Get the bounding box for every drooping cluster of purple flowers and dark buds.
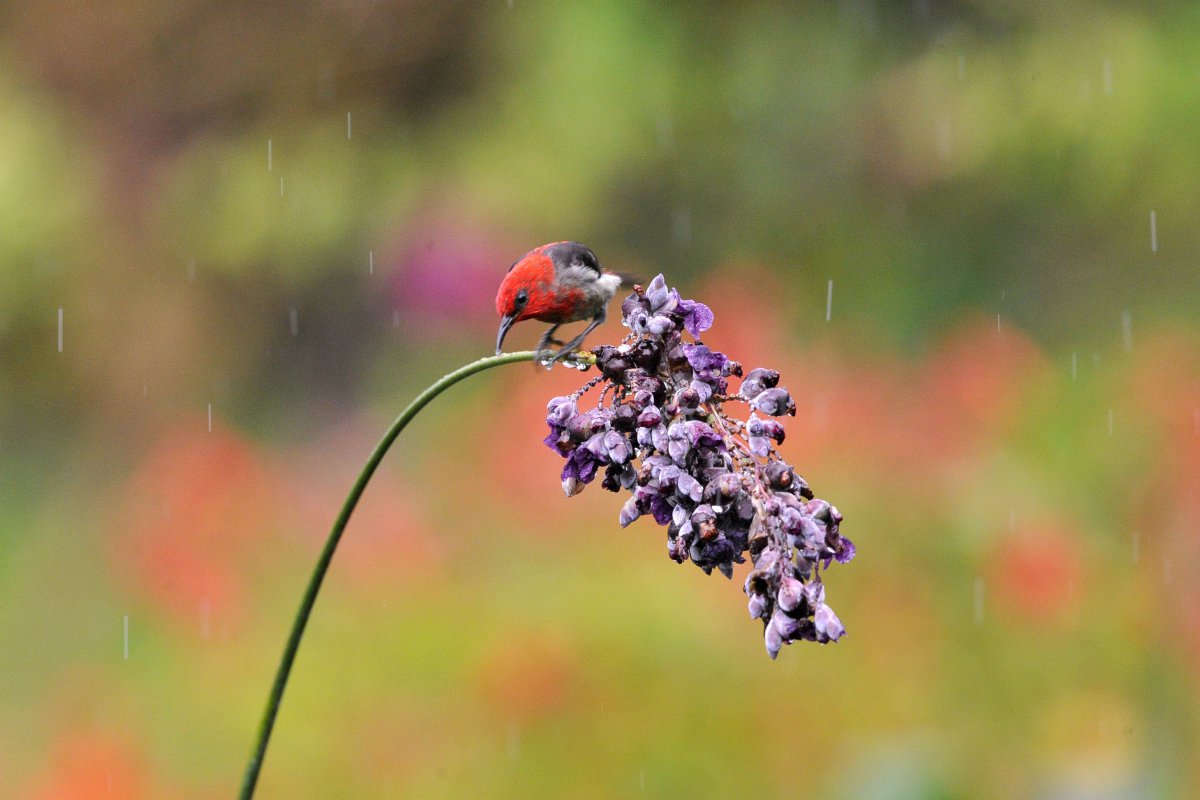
[546,275,854,658]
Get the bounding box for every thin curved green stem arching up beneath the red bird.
[238,350,534,800]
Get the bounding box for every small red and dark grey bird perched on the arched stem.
[496,241,624,363]
